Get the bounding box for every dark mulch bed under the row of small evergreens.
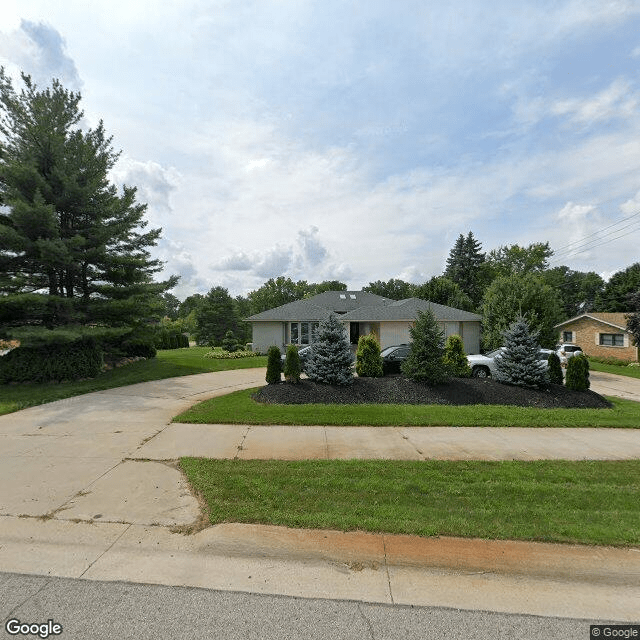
[253,375,612,409]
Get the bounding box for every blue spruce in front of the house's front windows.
[306,313,353,385]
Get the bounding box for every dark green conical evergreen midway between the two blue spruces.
[402,310,451,385]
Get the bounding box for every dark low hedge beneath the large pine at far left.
[0,336,102,384]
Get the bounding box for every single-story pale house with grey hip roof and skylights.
[246,291,481,353]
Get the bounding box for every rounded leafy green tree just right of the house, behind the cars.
[482,274,562,350]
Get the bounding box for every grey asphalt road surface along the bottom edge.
[0,573,616,640]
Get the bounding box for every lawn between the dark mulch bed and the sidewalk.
[174,389,640,428]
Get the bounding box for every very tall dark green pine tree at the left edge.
[0,68,177,327]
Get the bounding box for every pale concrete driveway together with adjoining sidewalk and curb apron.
[0,369,640,620]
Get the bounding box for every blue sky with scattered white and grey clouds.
[0,0,640,299]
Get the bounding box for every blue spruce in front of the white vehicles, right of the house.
[495,316,549,388]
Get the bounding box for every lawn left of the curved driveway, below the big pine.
[0,347,267,415]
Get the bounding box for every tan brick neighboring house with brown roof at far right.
[555,312,638,362]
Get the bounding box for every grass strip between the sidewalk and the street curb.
[181,458,640,545]
